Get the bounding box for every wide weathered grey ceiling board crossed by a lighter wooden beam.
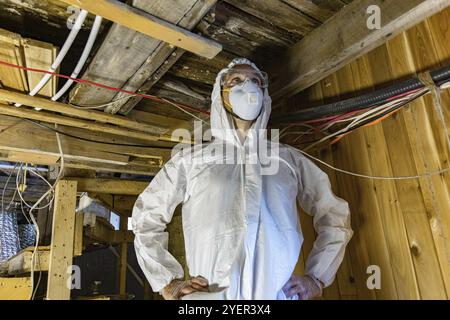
[70,0,216,114]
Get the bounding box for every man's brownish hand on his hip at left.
[161,276,209,300]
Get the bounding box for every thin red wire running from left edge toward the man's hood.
[0,60,210,116]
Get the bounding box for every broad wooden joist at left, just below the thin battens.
[0,114,171,175]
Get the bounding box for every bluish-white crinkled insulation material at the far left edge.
[0,212,19,263]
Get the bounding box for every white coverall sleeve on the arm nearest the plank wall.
[299,156,353,287]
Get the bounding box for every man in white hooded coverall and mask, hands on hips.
[133,58,352,299]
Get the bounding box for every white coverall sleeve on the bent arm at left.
[132,154,186,292]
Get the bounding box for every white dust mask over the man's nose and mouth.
[229,79,263,121]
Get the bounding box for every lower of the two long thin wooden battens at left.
[0,104,159,141]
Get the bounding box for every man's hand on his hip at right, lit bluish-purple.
[283,275,322,300]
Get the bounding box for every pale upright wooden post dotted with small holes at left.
[47,180,77,300]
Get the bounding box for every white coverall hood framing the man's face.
[211,58,272,144]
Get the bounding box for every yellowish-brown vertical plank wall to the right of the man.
[292,9,450,299]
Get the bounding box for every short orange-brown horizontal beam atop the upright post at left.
[71,178,149,195]
